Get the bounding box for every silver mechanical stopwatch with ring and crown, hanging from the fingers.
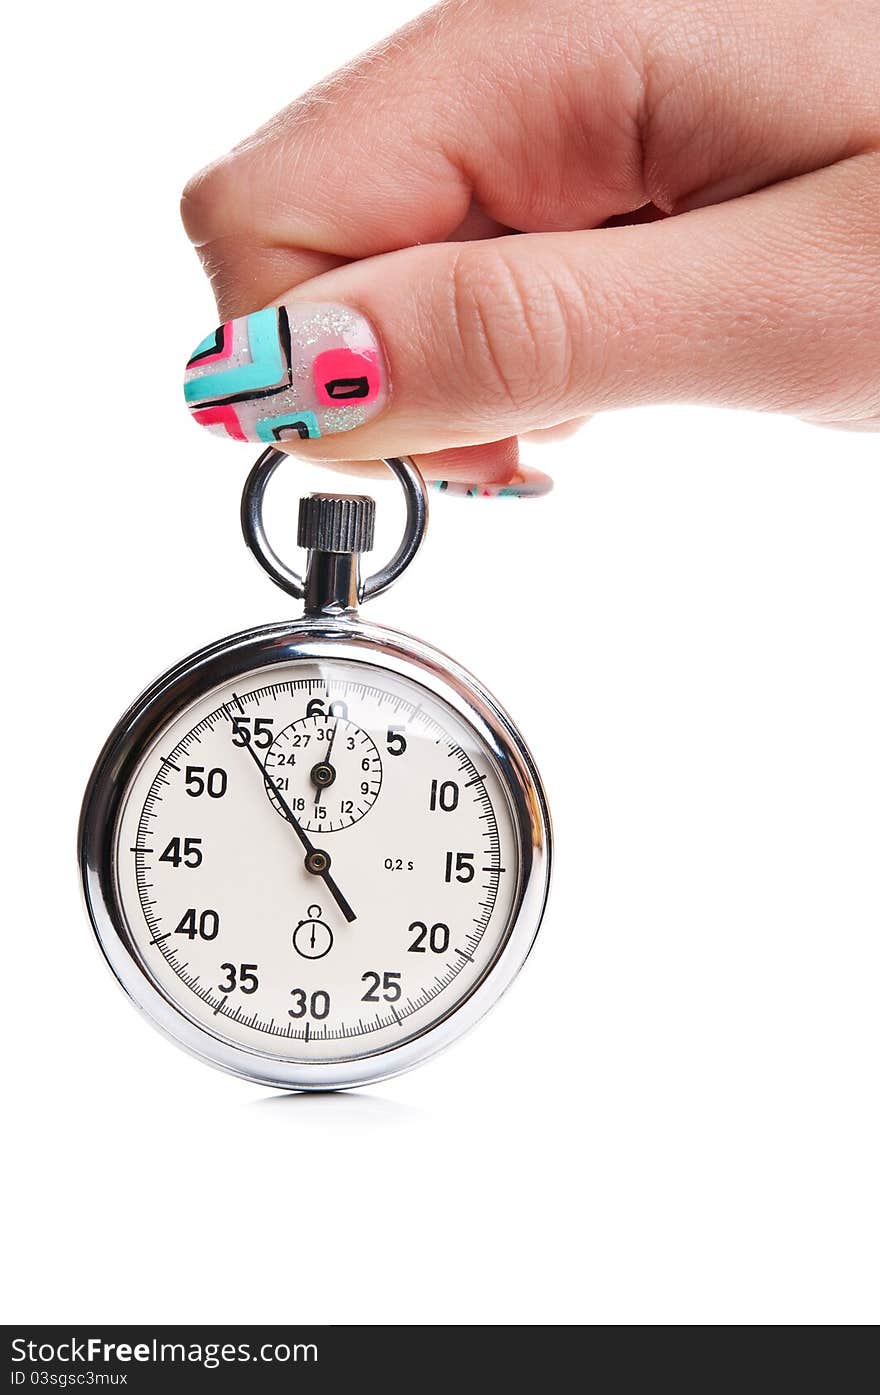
[79,449,551,1089]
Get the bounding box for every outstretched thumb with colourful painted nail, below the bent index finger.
[182,156,880,458]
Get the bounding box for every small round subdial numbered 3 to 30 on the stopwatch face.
[266,711,382,833]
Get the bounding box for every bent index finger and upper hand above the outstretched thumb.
[183,0,880,318]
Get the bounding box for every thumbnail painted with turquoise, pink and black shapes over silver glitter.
[184,304,388,445]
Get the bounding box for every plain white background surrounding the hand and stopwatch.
[1,0,880,1324]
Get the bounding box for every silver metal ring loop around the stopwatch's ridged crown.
[241,446,428,601]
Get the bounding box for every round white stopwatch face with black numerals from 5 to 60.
[82,624,552,1085]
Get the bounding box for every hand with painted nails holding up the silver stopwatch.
[183,0,880,491]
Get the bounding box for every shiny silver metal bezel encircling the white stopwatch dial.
[79,618,552,1089]
